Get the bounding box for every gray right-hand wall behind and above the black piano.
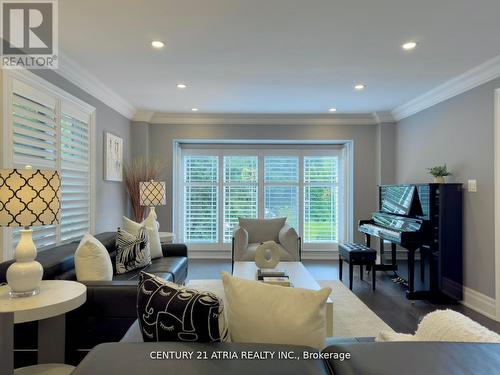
[395,79,500,298]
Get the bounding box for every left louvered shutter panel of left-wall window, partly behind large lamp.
[11,80,59,248]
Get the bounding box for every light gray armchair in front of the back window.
[231,217,302,274]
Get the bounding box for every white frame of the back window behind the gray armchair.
[172,140,353,252]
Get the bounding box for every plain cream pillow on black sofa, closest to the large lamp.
[75,233,113,281]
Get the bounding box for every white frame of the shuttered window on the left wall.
[0,69,96,260]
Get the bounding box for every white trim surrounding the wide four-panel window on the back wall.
[172,139,354,256]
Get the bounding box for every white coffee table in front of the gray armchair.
[233,262,333,337]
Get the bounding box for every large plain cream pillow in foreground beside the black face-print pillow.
[222,272,332,349]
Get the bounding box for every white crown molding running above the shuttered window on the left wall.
[55,51,136,119]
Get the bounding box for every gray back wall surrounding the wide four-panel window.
[145,123,378,244]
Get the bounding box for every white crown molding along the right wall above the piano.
[392,55,500,121]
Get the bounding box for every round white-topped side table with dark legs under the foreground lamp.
[0,280,87,374]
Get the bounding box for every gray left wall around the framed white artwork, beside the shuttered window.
[32,70,131,233]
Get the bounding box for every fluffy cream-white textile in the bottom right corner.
[375,309,500,343]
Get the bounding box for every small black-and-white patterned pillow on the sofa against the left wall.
[116,227,151,273]
